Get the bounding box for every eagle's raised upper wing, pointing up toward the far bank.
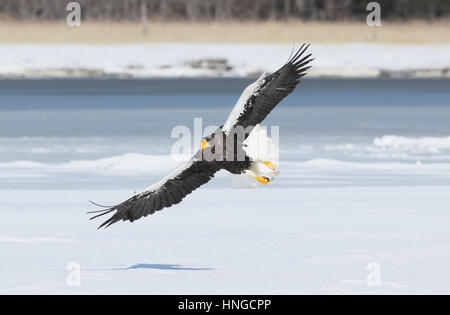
[222,44,313,133]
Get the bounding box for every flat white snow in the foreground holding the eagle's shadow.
[0,186,450,294]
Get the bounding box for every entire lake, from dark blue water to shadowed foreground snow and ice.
[0,79,450,294]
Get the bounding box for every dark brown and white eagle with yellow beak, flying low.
[89,44,314,229]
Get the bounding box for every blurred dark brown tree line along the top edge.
[0,0,450,21]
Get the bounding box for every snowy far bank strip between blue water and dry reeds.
[0,44,450,78]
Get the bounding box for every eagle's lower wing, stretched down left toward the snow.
[89,158,218,228]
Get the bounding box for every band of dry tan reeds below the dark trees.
[0,20,450,45]
